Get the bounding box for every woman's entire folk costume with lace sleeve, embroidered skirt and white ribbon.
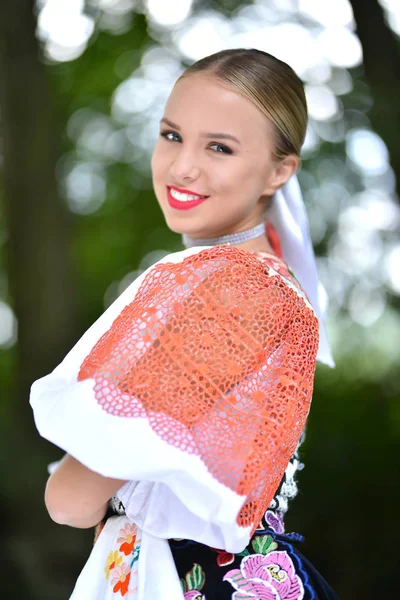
[31,176,336,600]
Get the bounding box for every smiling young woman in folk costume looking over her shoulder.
[31,49,336,600]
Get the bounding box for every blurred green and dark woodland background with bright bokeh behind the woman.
[0,0,400,600]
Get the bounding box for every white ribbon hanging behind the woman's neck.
[266,175,335,367]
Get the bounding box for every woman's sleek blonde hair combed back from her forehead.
[180,48,308,159]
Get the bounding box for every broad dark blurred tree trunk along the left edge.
[0,0,87,600]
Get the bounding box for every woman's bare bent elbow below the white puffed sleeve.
[45,454,125,528]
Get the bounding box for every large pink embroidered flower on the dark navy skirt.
[224,551,304,600]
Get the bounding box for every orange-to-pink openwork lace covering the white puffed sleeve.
[78,246,318,529]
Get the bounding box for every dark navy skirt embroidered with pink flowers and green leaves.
[169,528,338,600]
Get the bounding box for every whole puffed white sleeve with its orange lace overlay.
[31,246,318,552]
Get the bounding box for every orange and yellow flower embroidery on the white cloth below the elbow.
[104,517,141,596]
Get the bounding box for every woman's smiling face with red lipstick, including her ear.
[152,73,289,238]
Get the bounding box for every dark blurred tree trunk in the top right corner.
[350,0,400,195]
